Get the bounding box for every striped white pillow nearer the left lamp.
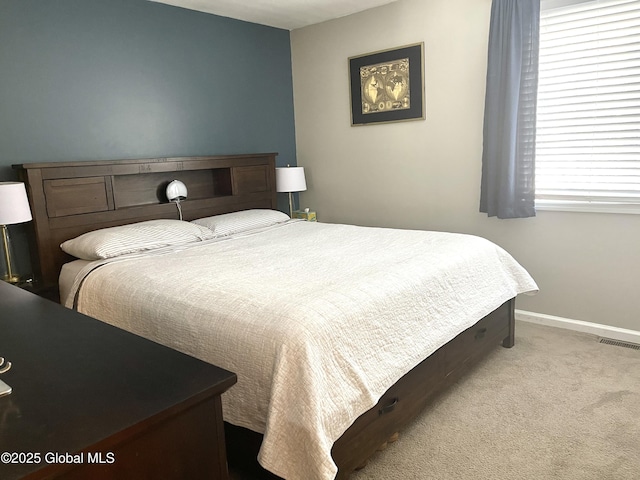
[60,219,214,260]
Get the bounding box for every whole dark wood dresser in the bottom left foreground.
[0,281,236,480]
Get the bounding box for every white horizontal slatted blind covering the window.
[536,0,640,213]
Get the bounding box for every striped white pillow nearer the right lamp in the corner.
[192,209,289,237]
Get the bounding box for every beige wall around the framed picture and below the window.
[291,0,640,331]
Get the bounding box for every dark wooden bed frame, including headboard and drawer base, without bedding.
[13,153,514,479]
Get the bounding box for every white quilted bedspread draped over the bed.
[65,222,537,480]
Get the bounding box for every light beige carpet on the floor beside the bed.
[232,322,640,480]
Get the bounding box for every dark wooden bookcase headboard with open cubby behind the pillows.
[13,153,277,285]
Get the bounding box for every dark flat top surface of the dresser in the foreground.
[0,281,236,479]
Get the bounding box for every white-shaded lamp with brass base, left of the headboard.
[0,182,31,283]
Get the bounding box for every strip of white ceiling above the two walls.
[150,0,397,30]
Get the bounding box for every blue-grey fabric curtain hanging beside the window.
[480,0,540,218]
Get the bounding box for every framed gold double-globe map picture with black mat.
[349,43,425,126]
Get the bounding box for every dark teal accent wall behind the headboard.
[0,0,296,273]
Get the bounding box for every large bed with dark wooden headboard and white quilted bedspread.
[15,154,537,480]
